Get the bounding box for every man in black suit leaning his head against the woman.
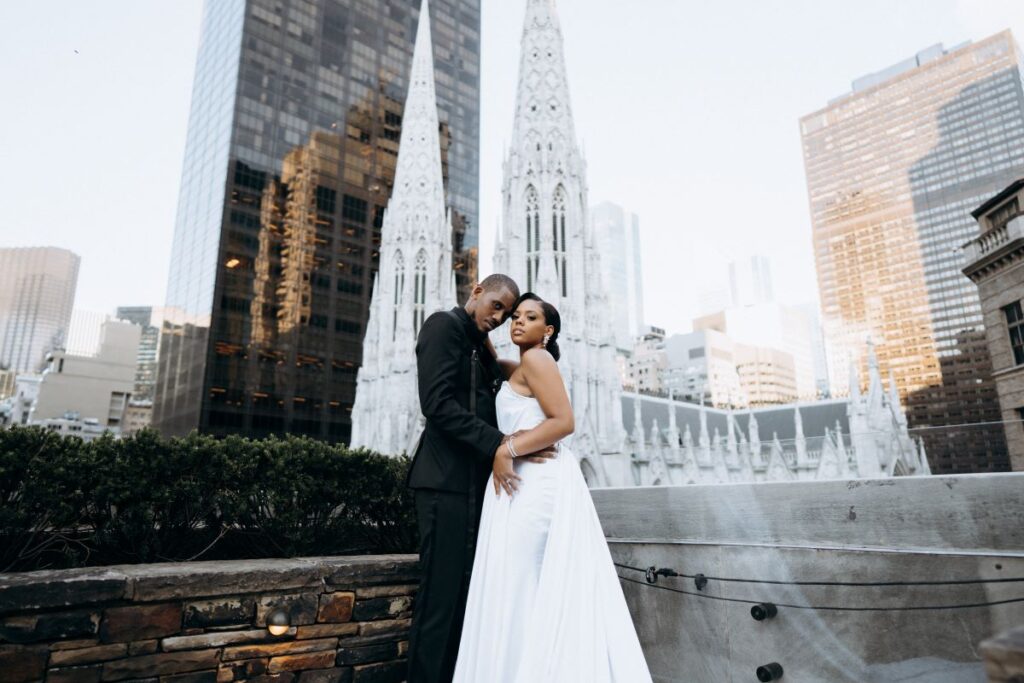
[408,273,553,683]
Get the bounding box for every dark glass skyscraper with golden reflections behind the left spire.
[154,0,480,441]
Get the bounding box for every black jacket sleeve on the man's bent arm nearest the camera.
[416,313,504,460]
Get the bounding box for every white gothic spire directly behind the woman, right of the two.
[495,0,630,485]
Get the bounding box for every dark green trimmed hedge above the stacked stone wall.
[0,427,416,571]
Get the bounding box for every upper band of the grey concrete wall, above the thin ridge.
[593,472,1024,554]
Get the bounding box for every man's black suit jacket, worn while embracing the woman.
[409,307,504,493]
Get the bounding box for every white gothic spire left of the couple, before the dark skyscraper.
[351,0,456,455]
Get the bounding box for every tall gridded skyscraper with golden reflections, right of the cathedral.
[801,31,1024,473]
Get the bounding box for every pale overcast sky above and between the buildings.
[0,0,1024,332]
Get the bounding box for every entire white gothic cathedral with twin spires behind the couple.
[351,0,928,486]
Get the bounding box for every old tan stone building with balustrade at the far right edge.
[964,178,1024,470]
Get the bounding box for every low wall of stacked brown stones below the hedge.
[0,555,418,683]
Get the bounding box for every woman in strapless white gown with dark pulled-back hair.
[454,294,651,683]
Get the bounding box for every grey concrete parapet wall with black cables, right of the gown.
[593,473,1024,683]
